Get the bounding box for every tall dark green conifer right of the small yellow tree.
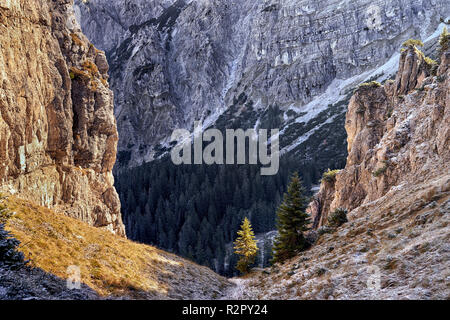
[273,172,310,263]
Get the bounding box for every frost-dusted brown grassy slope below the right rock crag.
[228,182,450,299]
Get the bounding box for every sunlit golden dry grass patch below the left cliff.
[3,197,187,296]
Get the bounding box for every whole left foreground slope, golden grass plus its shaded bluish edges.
[0,197,231,299]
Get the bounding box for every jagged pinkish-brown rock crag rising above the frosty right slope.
[312,47,450,225]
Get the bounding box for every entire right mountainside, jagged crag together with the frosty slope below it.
[230,47,450,299]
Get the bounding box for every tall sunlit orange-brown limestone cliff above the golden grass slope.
[0,0,125,235]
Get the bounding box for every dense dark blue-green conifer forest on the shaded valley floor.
[116,157,324,276]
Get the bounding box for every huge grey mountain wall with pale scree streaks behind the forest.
[75,0,450,168]
